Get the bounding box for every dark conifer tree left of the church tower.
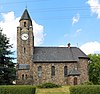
[0,30,16,85]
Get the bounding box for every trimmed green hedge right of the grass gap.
[70,85,100,94]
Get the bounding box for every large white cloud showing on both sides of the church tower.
[0,12,44,50]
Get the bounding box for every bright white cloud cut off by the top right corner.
[87,0,100,18]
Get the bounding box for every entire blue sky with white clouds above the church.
[0,0,100,59]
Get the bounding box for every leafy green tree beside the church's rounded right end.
[89,54,100,85]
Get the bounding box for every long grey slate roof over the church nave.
[33,47,89,62]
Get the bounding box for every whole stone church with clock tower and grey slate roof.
[16,9,89,85]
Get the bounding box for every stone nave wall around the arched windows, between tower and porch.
[33,63,77,85]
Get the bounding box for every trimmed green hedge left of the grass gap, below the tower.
[0,85,36,94]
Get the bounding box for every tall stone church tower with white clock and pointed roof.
[17,9,34,84]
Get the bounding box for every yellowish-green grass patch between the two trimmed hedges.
[36,86,70,94]
